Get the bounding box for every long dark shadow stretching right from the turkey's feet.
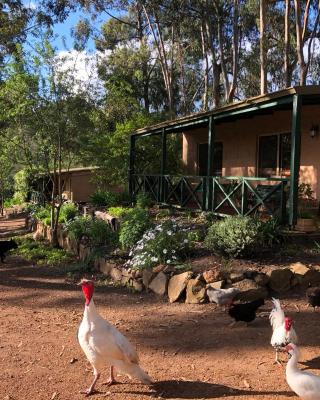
[122,380,295,399]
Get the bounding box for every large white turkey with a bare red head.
[78,279,152,396]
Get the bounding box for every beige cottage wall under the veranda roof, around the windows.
[182,105,320,198]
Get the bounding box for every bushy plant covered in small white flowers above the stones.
[127,221,197,269]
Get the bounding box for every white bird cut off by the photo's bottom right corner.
[285,343,320,400]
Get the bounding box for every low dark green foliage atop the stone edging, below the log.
[66,217,118,246]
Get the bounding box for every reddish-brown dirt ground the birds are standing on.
[0,222,320,400]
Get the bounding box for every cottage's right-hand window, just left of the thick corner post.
[258,133,291,177]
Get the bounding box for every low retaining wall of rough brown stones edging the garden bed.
[34,222,320,304]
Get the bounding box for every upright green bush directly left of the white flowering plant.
[119,208,152,249]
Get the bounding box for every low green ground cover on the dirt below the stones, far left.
[15,238,72,265]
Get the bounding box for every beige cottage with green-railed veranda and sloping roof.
[129,86,320,226]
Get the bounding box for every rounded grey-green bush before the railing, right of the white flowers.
[205,216,262,257]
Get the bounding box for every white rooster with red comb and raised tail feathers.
[269,299,298,364]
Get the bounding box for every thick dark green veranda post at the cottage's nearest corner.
[289,94,301,227]
